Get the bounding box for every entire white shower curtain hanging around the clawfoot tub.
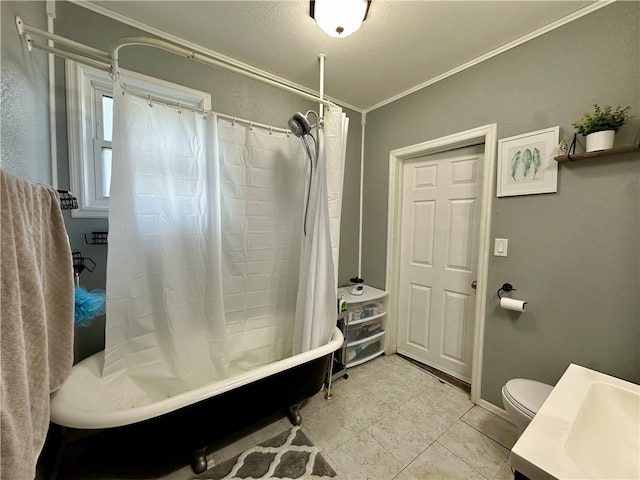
[103,88,346,406]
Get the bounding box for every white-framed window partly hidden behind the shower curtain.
[66,60,211,218]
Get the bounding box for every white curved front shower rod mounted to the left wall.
[16,16,335,110]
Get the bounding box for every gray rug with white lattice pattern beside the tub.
[194,427,336,480]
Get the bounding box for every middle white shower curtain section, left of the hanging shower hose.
[218,119,309,371]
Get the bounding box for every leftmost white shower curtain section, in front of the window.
[103,86,229,405]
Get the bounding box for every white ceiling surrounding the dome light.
[86,0,608,110]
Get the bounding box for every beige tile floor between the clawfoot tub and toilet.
[59,355,517,480]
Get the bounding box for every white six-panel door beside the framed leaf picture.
[398,145,484,381]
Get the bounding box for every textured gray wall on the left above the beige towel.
[0,1,51,184]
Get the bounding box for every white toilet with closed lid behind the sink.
[502,378,553,435]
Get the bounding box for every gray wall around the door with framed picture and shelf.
[363,2,640,406]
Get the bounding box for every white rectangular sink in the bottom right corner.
[511,364,640,480]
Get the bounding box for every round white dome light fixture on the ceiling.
[310,0,371,38]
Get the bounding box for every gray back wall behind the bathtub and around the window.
[50,2,360,360]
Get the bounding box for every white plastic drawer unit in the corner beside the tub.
[338,285,387,368]
